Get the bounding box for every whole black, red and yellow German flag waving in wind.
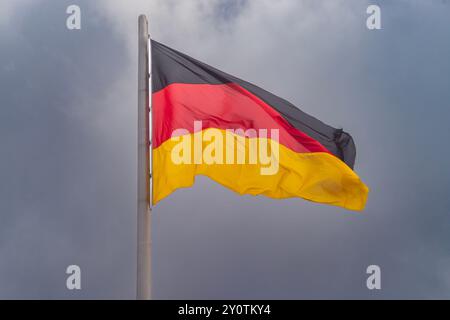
[151,40,369,210]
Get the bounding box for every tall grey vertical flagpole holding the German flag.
[136,15,152,300]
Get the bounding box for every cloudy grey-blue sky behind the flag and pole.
[0,0,450,299]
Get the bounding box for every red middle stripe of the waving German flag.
[152,83,330,153]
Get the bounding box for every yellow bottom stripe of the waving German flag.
[153,129,369,211]
